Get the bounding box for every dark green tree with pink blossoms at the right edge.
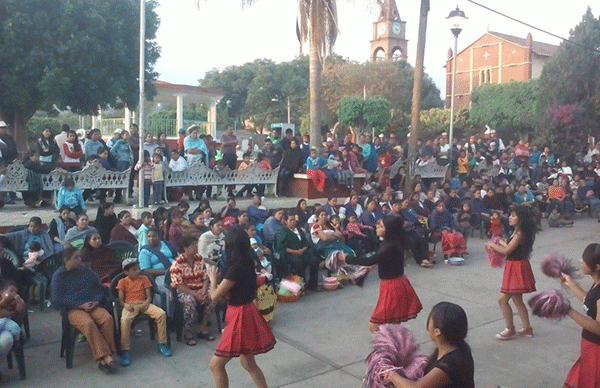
[538,8,600,157]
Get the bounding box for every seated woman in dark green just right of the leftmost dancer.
[273,213,320,290]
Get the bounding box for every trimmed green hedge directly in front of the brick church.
[470,80,540,134]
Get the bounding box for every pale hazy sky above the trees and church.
[156,0,600,96]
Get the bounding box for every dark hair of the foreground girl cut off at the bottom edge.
[425,302,471,371]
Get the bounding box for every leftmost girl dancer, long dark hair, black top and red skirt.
[208,228,276,388]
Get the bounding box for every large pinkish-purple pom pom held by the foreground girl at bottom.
[363,324,429,388]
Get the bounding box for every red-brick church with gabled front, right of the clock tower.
[446,31,558,110]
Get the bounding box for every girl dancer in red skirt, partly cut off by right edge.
[561,244,600,388]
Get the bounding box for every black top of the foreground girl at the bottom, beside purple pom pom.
[425,348,475,388]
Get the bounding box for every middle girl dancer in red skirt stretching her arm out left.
[343,216,423,333]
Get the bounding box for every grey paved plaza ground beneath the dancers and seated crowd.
[0,198,600,388]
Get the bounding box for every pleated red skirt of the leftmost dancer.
[215,302,277,357]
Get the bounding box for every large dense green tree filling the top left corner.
[0,0,159,145]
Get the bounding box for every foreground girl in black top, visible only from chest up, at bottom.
[387,302,475,388]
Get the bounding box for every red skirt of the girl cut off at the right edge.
[563,338,600,388]
